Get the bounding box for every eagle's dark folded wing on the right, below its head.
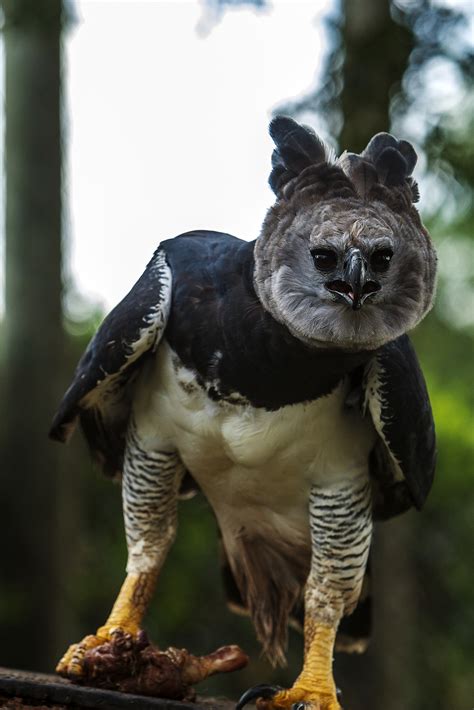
[364,335,436,518]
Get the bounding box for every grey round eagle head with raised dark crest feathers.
[255,116,436,350]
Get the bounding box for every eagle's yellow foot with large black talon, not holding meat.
[236,684,342,710]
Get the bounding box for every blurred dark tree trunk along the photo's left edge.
[0,0,63,669]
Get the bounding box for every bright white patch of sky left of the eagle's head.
[66,0,333,318]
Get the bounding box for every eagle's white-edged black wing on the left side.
[50,248,172,475]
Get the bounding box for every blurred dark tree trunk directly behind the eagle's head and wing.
[338,0,419,710]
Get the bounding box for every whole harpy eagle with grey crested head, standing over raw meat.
[51,116,436,710]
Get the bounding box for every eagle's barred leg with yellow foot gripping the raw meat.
[56,423,184,679]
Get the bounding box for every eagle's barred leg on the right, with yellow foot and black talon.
[238,475,372,710]
